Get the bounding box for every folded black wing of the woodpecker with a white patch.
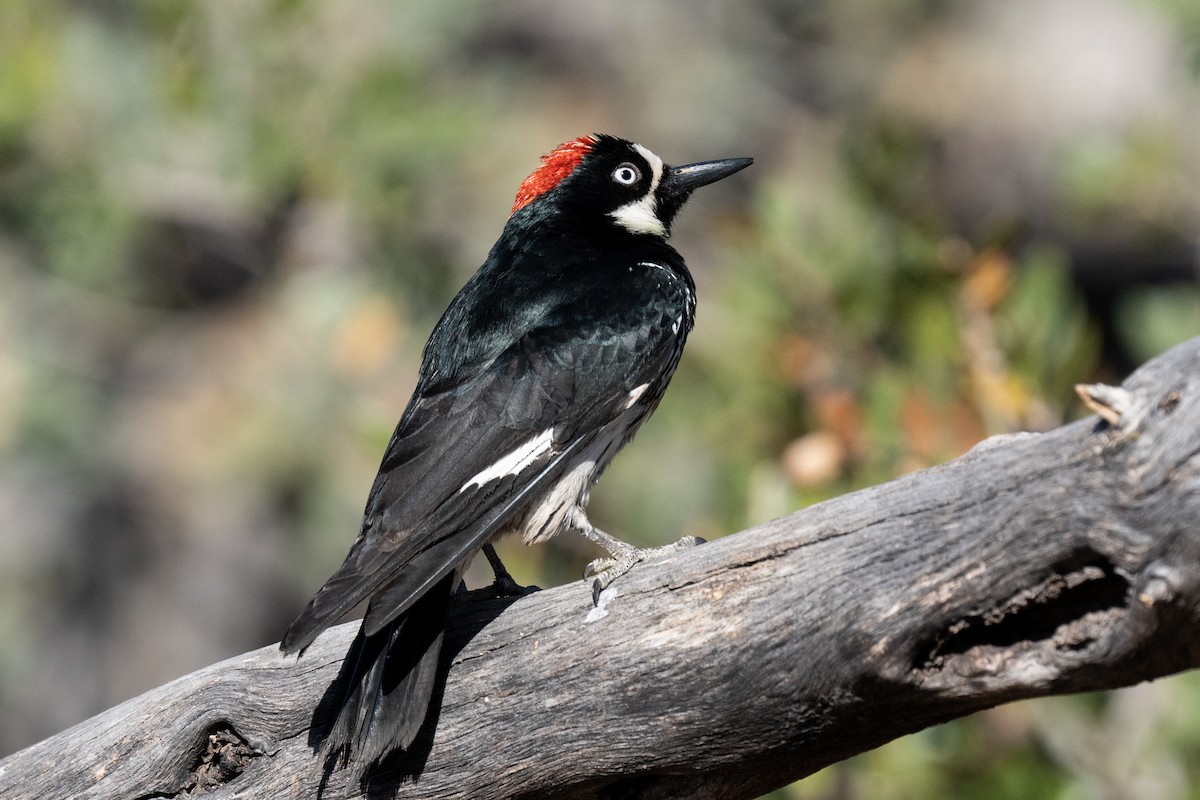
[274,296,680,652]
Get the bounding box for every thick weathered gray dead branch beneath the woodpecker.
[0,339,1200,800]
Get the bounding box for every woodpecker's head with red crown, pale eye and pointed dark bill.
[512,134,754,239]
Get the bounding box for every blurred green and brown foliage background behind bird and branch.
[0,0,1200,800]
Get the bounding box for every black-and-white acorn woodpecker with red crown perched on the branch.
[280,134,751,774]
